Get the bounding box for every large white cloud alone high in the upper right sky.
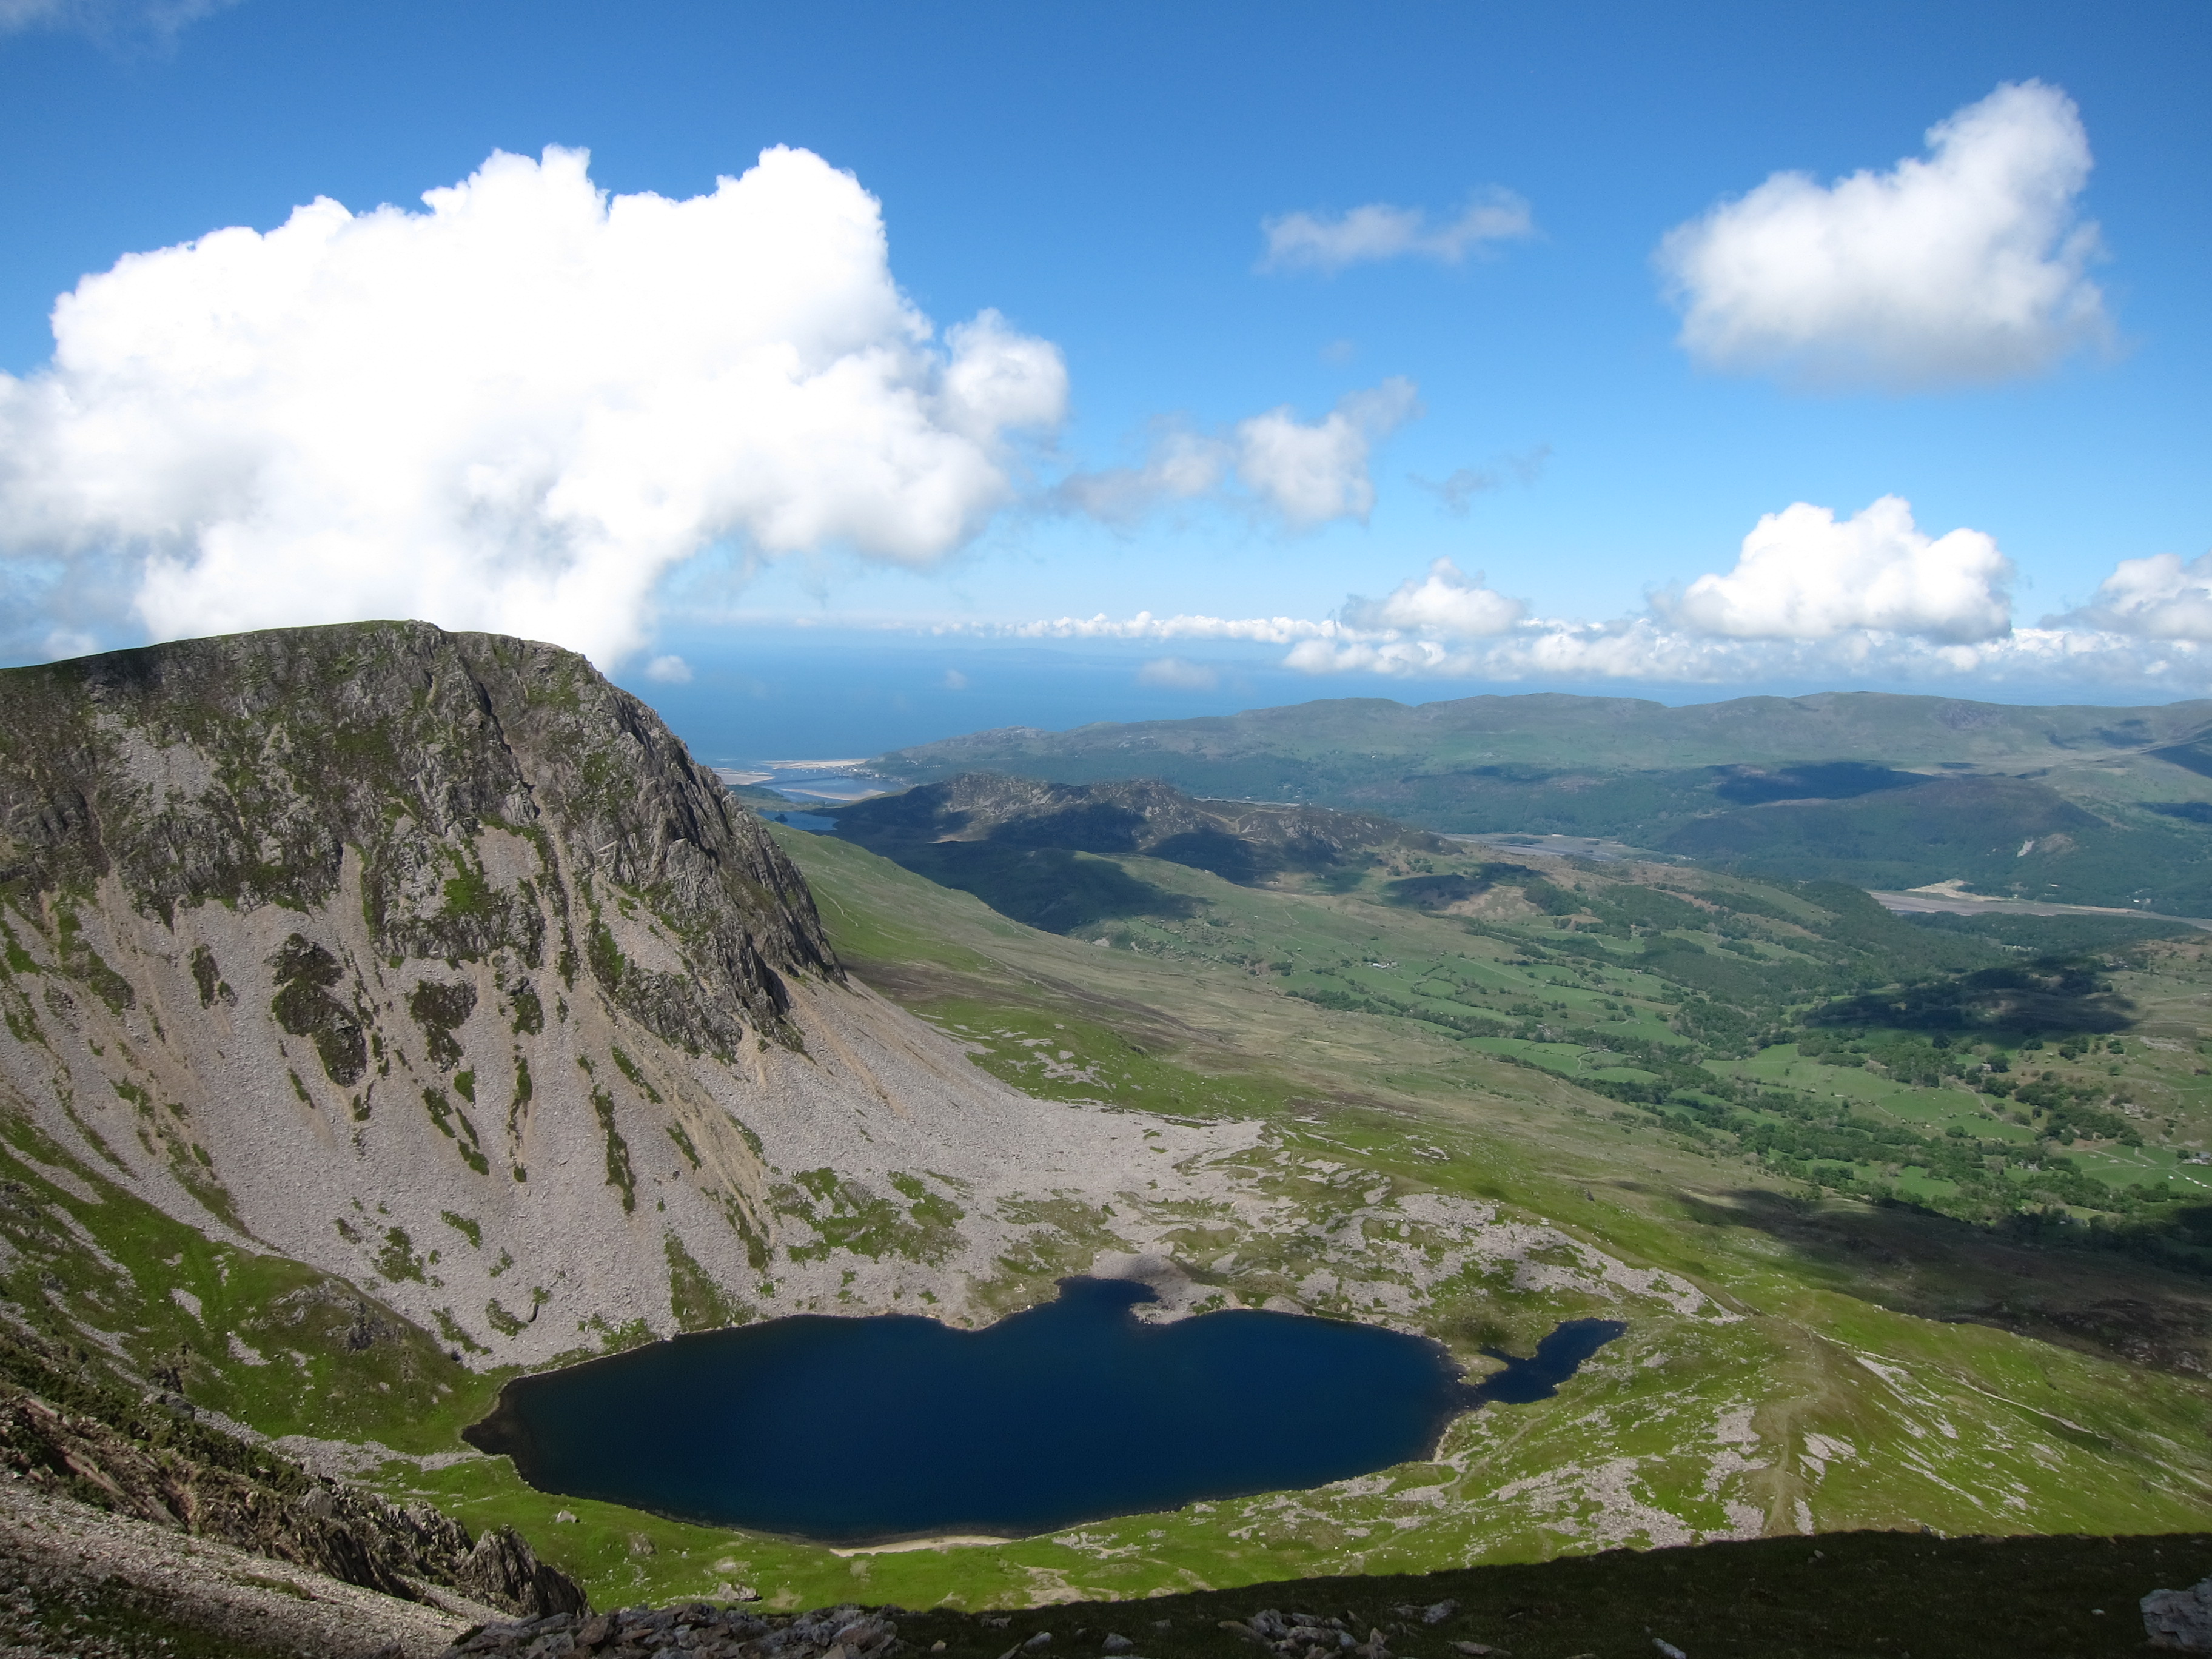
[1657,82,2106,387]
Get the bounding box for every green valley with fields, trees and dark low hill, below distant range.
[836,774,2212,1270]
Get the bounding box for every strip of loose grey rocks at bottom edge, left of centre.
[444,1601,898,1659]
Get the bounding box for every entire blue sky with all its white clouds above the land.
[0,0,2212,748]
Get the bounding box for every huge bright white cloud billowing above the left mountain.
[0,148,1066,662]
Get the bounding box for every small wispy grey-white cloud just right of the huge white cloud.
[1057,376,1420,529]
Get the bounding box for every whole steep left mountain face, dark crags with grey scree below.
[0,624,1185,1362]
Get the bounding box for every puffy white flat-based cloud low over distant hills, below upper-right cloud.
[1666,495,2013,642]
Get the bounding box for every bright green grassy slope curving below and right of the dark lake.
[412,832,2212,1606]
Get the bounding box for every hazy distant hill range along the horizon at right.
[871,692,2212,916]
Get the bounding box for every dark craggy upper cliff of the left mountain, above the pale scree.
[0,622,836,1057]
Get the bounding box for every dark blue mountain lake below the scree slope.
[467,1279,1626,1544]
